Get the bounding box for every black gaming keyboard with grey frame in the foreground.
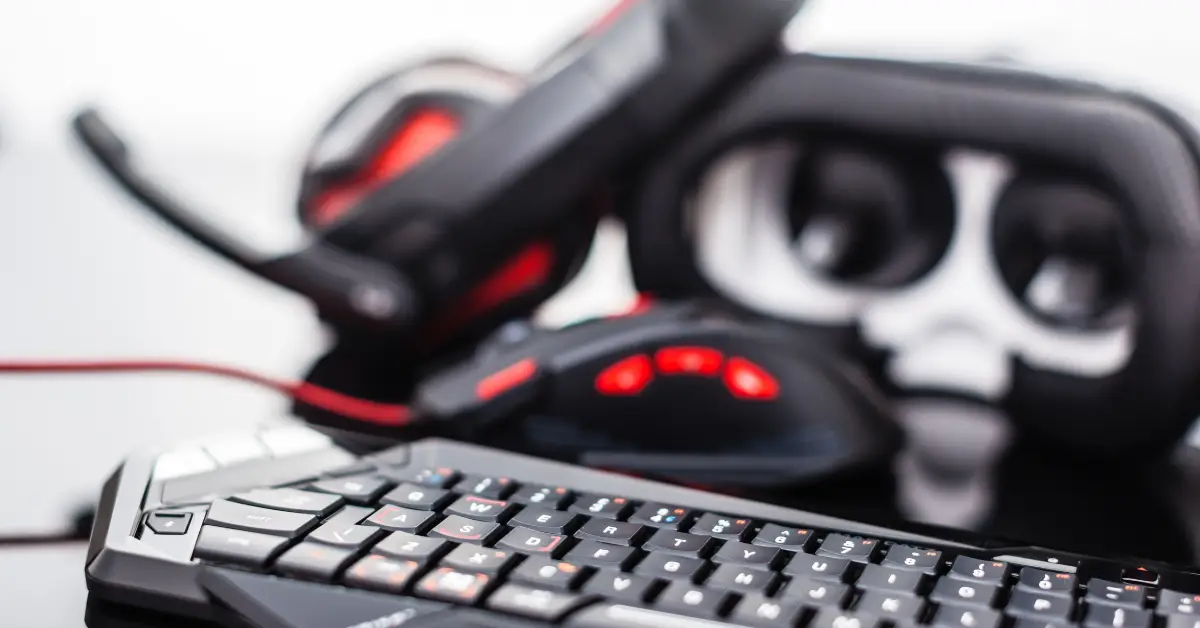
[86,426,1200,628]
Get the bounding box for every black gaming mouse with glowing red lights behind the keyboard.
[413,301,902,489]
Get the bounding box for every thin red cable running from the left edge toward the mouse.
[0,360,412,426]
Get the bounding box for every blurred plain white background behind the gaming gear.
[0,0,1200,533]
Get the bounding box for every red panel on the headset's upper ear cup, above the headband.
[312,109,460,225]
